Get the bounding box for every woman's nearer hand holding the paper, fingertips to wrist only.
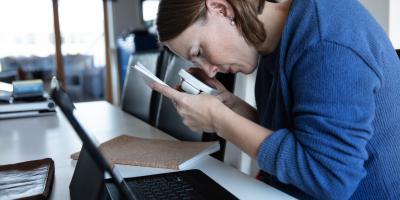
[151,83,224,132]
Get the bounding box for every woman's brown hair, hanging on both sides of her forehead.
[156,0,267,48]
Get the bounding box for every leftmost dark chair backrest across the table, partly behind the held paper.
[121,51,160,125]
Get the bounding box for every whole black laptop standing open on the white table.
[51,78,237,200]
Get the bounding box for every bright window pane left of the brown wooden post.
[0,0,55,83]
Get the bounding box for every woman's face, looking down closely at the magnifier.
[165,10,258,77]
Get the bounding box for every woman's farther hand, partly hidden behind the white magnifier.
[187,68,237,109]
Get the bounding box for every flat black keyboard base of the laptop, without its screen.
[105,169,237,200]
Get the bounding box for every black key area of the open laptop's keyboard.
[128,174,203,199]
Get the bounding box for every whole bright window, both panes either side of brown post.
[0,0,106,101]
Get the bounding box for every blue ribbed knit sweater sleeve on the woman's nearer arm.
[257,42,380,199]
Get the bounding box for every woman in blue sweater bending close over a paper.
[152,0,400,199]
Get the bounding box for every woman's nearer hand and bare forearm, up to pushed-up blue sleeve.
[151,77,272,158]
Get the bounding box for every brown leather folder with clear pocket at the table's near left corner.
[0,158,54,200]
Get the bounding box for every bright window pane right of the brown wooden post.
[58,0,105,101]
